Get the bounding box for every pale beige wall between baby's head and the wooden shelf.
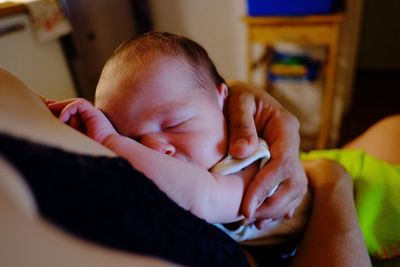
[149,0,246,80]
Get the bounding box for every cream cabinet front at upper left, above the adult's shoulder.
[0,14,76,100]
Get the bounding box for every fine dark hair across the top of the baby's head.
[107,32,225,87]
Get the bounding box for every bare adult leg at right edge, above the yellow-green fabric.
[343,115,400,164]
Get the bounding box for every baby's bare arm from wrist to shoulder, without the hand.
[103,135,257,223]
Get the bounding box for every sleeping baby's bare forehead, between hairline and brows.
[103,57,217,109]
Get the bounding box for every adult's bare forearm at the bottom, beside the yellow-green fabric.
[293,181,371,267]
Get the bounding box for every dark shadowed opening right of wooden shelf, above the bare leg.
[339,0,400,145]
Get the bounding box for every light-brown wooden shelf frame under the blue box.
[244,13,345,149]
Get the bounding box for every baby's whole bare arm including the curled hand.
[48,99,253,223]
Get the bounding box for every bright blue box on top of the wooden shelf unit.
[247,0,335,16]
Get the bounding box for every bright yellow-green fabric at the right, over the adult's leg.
[300,149,400,259]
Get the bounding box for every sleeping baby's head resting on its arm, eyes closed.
[95,33,227,169]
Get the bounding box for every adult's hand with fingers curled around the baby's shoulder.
[228,82,307,228]
